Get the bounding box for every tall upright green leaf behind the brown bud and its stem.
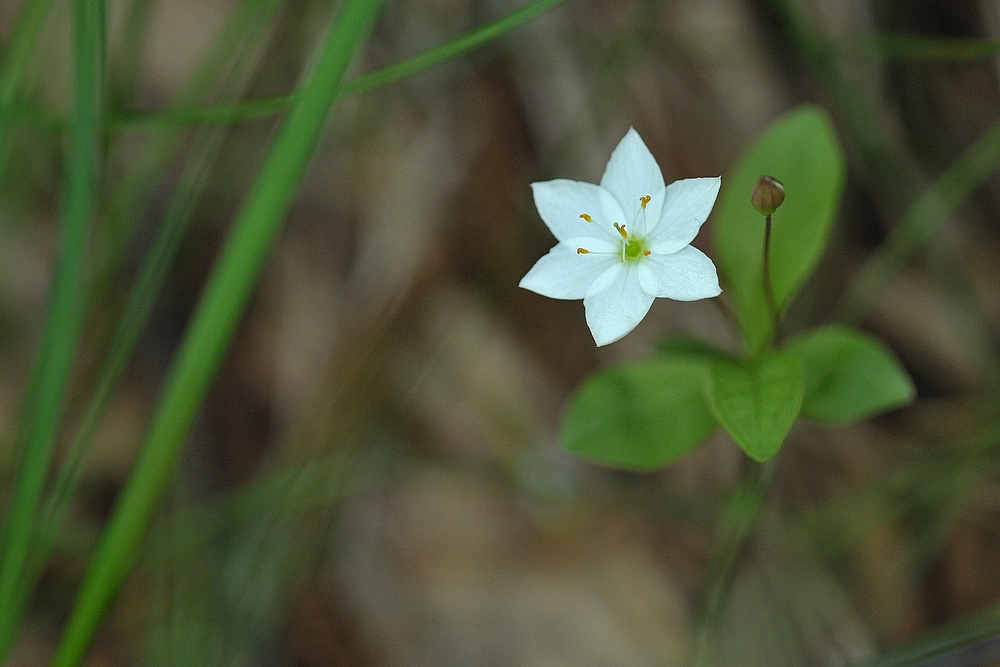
[715,106,845,351]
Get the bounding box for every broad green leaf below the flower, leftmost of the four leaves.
[562,354,717,470]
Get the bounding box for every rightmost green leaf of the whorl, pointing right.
[785,325,916,424]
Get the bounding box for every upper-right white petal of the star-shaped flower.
[649,176,722,253]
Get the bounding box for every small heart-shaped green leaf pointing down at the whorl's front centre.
[708,352,803,461]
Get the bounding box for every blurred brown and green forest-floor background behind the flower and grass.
[0,0,1000,667]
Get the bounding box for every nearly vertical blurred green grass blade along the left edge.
[0,0,104,660]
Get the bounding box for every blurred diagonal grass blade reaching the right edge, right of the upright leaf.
[835,123,1000,322]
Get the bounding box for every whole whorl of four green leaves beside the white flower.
[563,106,914,470]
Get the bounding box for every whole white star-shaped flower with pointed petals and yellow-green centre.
[520,128,722,345]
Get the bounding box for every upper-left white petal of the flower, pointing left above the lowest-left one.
[531,178,623,241]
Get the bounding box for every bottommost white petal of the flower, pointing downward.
[583,261,653,345]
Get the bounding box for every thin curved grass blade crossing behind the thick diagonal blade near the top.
[111,0,564,128]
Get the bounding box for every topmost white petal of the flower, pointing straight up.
[601,127,664,231]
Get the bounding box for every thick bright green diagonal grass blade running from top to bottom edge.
[53,0,382,667]
